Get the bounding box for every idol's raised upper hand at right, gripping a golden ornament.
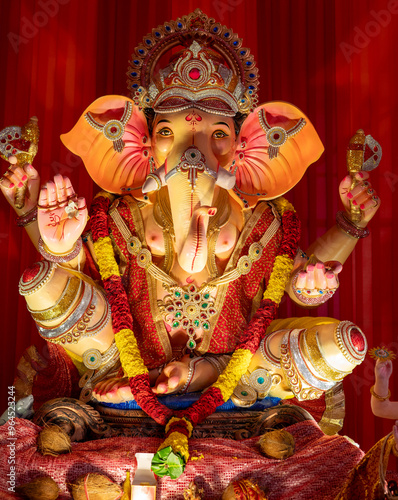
[339,172,381,227]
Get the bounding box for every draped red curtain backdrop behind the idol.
[0,0,398,450]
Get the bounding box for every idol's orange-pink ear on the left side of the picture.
[61,95,152,198]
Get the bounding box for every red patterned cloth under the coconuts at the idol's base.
[0,419,363,500]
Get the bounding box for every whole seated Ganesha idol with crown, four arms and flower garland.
[1,10,380,472]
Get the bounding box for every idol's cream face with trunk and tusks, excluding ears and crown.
[143,109,236,273]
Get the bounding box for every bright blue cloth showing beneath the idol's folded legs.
[101,392,280,412]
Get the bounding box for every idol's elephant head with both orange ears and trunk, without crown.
[62,96,323,273]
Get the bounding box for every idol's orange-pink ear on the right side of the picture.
[234,102,324,207]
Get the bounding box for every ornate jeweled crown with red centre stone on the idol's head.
[127,9,258,116]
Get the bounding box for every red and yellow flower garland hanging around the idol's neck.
[91,193,300,478]
